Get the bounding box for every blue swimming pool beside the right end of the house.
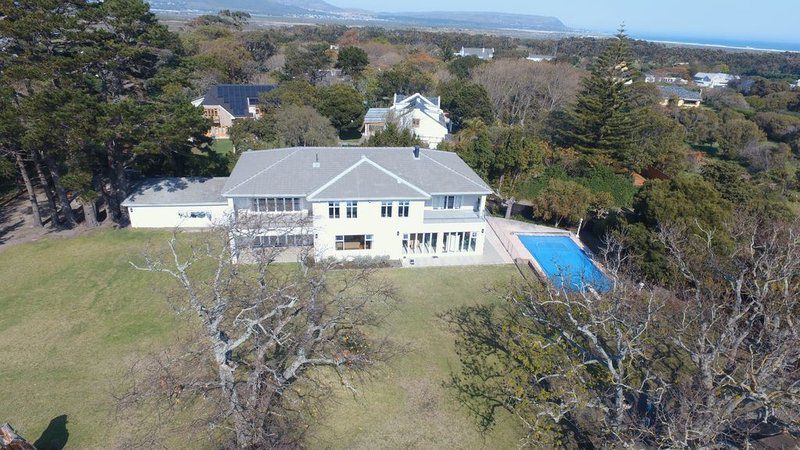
[517,234,610,291]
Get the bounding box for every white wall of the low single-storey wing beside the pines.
[128,203,230,228]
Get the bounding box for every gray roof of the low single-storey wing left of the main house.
[122,177,228,206]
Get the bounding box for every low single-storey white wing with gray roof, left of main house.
[122,177,229,228]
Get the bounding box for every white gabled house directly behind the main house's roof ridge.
[363,93,450,149]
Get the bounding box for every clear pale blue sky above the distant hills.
[329,0,800,43]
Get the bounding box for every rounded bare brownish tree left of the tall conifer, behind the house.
[472,60,582,124]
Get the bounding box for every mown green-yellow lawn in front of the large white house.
[0,230,518,449]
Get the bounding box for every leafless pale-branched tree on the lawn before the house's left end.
[120,214,394,448]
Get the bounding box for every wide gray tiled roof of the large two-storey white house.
[222,147,492,200]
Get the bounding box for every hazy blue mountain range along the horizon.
[150,0,569,32]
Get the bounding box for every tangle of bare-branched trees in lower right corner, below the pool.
[448,212,800,448]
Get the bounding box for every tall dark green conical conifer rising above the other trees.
[561,28,640,162]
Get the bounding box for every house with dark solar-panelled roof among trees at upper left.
[192,84,275,138]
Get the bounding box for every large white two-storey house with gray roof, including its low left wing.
[125,147,492,259]
